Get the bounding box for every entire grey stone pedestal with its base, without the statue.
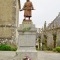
[17,20,37,60]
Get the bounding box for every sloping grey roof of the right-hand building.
[47,12,60,29]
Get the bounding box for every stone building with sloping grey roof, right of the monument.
[43,13,60,48]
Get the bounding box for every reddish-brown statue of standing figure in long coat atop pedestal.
[20,0,34,20]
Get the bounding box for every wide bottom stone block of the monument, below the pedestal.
[16,50,37,60]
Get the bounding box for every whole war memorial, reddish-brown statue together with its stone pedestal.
[17,0,37,60]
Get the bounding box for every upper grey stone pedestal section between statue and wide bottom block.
[18,20,36,49]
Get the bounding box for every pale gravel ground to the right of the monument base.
[38,51,60,60]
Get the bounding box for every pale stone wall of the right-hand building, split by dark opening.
[46,28,60,47]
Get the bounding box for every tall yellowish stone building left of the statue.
[0,0,20,43]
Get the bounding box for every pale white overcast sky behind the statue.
[19,0,60,28]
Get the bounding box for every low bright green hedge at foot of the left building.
[0,44,17,51]
